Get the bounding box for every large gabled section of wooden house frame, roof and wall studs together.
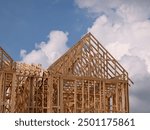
[48,33,133,112]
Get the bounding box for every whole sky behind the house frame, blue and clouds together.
[0,0,150,112]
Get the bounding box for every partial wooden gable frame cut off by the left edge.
[0,47,15,112]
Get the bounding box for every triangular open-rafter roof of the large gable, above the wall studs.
[48,33,132,82]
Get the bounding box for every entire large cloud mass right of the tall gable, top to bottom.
[75,0,150,112]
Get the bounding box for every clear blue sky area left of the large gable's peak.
[0,0,92,60]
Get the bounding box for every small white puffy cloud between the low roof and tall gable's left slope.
[20,31,68,68]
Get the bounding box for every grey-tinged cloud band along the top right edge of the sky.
[75,0,150,21]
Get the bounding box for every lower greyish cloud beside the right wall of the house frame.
[121,55,150,112]
